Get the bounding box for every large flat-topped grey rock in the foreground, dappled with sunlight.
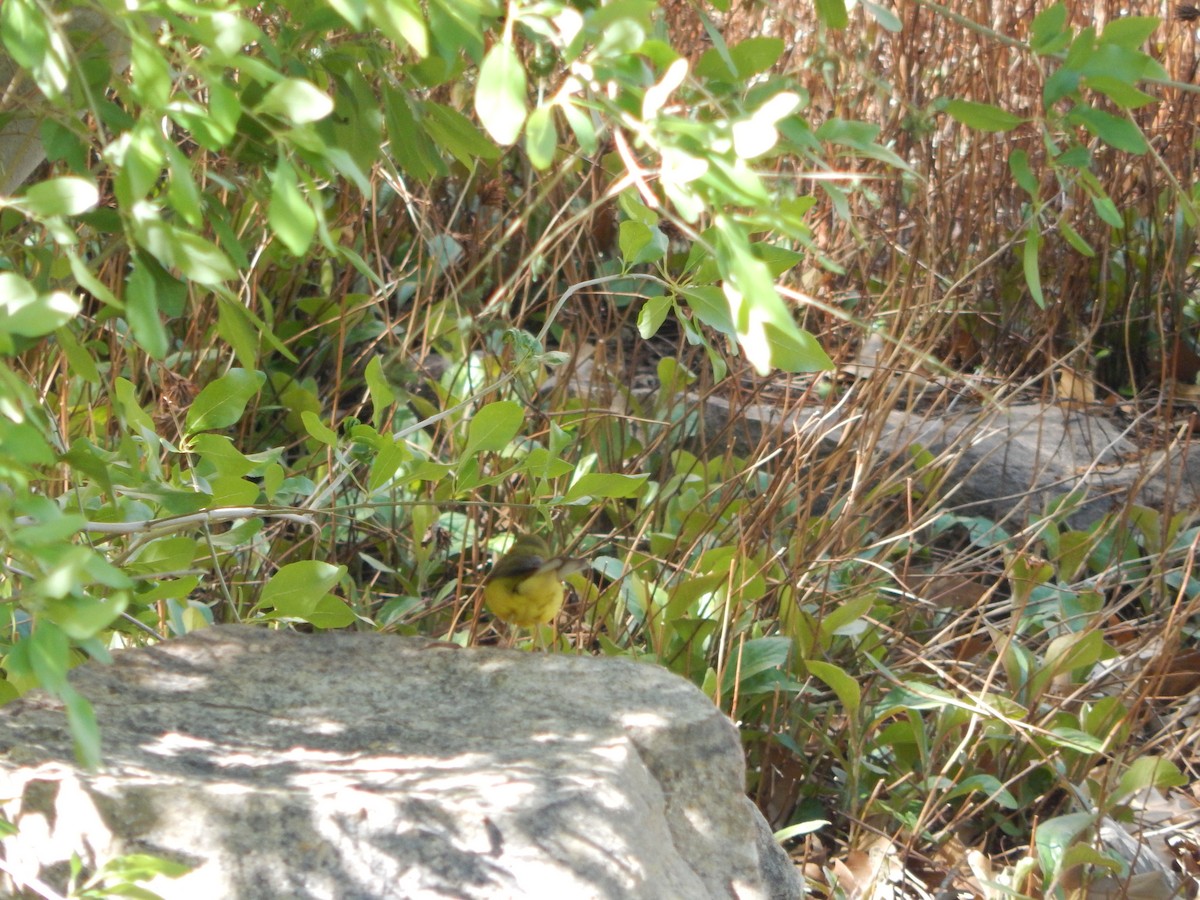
[0,626,802,900]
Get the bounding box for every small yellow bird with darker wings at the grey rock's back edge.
[484,535,588,628]
